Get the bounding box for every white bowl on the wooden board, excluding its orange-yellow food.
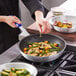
[49,15,76,33]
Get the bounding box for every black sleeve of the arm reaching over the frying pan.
[22,0,44,18]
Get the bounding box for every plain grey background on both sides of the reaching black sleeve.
[19,0,66,28]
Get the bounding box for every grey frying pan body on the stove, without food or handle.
[19,34,66,62]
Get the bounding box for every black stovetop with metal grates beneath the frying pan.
[12,46,76,76]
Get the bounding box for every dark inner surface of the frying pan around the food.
[19,34,65,51]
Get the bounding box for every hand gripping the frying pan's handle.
[3,16,21,28]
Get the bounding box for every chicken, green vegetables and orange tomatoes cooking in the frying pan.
[23,41,60,57]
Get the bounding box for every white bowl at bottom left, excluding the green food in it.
[0,62,38,76]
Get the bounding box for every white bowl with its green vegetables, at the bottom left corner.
[0,62,38,76]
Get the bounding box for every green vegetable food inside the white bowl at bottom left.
[0,68,31,76]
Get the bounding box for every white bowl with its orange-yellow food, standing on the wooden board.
[49,15,76,33]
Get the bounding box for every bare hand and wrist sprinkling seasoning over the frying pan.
[35,11,51,34]
